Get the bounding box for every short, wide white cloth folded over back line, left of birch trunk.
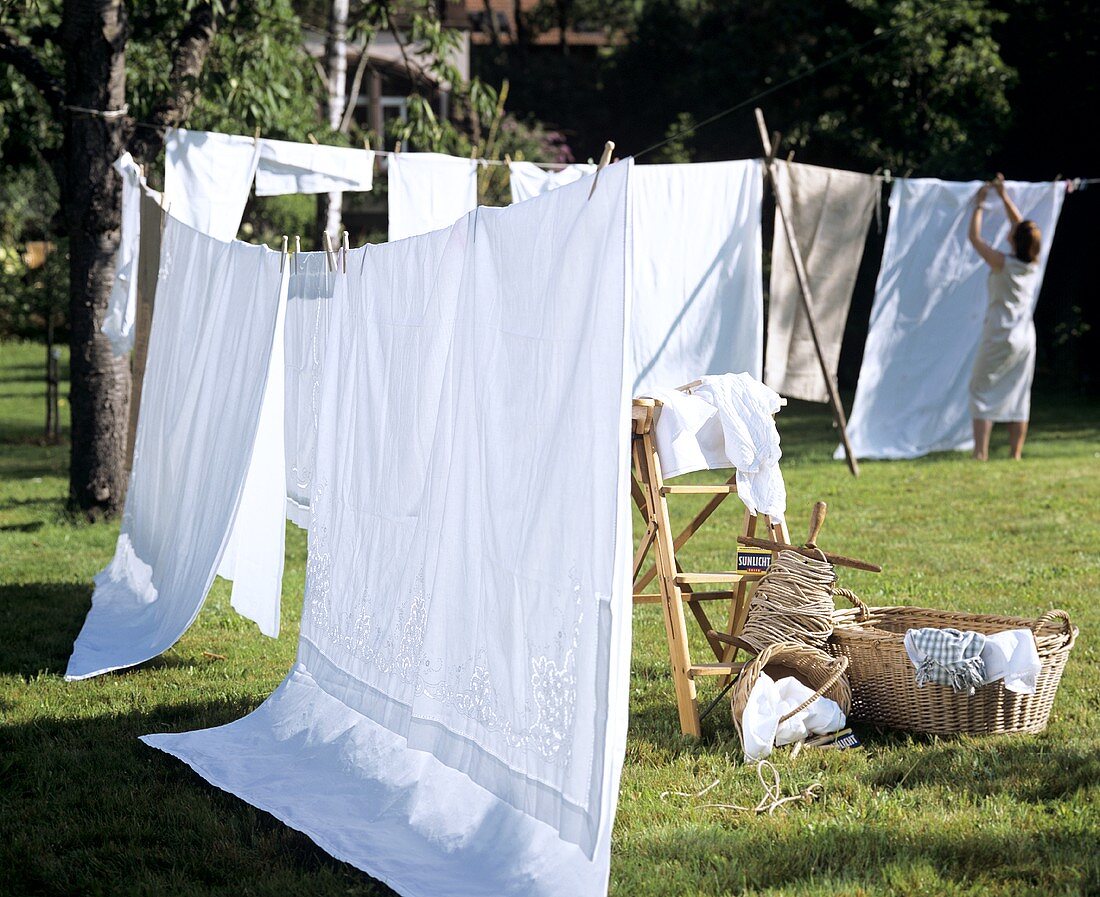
[256,139,374,196]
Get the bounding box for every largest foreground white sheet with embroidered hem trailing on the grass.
[144,162,631,897]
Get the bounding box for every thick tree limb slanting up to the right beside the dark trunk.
[130,2,223,164]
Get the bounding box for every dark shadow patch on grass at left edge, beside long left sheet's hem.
[0,582,91,678]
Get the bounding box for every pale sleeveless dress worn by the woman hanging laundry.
[970,255,1040,422]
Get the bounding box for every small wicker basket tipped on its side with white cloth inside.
[729,642,851,743]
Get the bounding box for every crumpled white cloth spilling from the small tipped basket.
[741,672,845,761]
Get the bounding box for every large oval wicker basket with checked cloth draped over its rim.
[827,589,1078,735]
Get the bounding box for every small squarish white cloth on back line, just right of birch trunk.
[386,153,480,240]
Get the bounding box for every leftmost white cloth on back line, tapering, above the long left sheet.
[164,128,260,240]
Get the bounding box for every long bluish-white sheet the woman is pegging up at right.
[835,178,1065,459]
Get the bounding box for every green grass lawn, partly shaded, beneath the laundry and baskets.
[0,343,1100,897]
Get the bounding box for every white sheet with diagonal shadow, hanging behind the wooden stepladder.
[633,160,763,395]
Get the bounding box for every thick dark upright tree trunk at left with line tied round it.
[61,0,130,519]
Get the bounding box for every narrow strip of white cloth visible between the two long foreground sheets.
[273,251,336,530]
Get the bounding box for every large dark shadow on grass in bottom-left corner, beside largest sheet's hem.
[0,699,392,897]
